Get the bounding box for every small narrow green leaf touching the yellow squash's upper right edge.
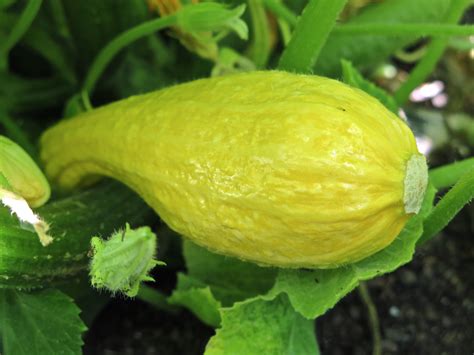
[341,59,398,116]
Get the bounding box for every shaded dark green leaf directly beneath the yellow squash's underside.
[183,241,277,306]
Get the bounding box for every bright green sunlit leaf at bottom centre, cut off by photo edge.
[205,295,319,355]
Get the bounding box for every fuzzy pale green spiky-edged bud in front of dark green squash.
[89,224,164,297]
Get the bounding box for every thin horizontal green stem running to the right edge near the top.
[333,23,474,37]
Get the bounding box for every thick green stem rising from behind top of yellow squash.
[278,0,347,73]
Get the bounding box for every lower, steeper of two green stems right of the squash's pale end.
[417,168,474,245]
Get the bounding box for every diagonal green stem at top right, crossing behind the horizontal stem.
[394,0,470,106]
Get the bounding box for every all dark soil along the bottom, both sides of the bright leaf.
[85,211,474,355]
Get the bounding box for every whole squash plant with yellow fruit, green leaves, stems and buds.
[0,0,474,354]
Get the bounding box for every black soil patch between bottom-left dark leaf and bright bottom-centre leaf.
[84,300,214,355]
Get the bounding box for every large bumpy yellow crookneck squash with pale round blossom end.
[42,71,427,268]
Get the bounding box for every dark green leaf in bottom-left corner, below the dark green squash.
[0,289,86,355]
